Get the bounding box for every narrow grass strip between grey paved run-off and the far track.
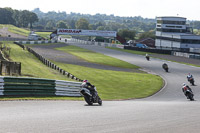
[56,46,139,69]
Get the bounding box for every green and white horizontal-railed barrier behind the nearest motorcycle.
[0,77,81,97]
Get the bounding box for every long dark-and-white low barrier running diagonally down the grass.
[15,42,83,81]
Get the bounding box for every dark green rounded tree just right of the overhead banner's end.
[118,29,136,40]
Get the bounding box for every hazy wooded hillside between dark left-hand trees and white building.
[33,8,156,40]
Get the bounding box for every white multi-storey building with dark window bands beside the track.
[155,17,200,49]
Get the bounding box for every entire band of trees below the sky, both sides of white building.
[0,8,200,39]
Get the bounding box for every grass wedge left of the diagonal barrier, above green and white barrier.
[5,42,76,80]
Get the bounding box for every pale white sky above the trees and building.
[0,0,200,21]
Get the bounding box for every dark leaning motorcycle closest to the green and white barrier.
[80,87,102,105]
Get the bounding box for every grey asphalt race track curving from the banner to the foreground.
[0,39,200,133]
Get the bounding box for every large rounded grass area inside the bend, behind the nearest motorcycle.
[51,62,163,100]
